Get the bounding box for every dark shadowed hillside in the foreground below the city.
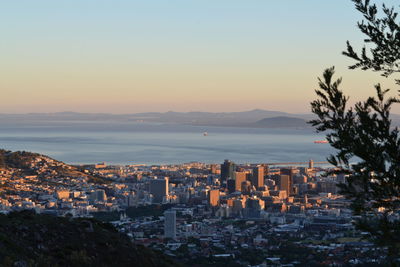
[0,211,176,267]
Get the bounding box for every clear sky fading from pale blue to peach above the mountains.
[0,0,400,113]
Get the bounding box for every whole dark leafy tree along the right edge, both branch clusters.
[310,0,400,263]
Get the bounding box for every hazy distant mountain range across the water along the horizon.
[0,109,400,128]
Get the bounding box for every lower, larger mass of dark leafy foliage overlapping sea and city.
[310,68,400,260]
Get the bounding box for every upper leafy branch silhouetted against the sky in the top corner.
[343,0,400,84]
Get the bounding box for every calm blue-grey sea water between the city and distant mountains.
[0,121,332,164]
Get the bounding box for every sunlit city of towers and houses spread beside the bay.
[0,151,383,266]
